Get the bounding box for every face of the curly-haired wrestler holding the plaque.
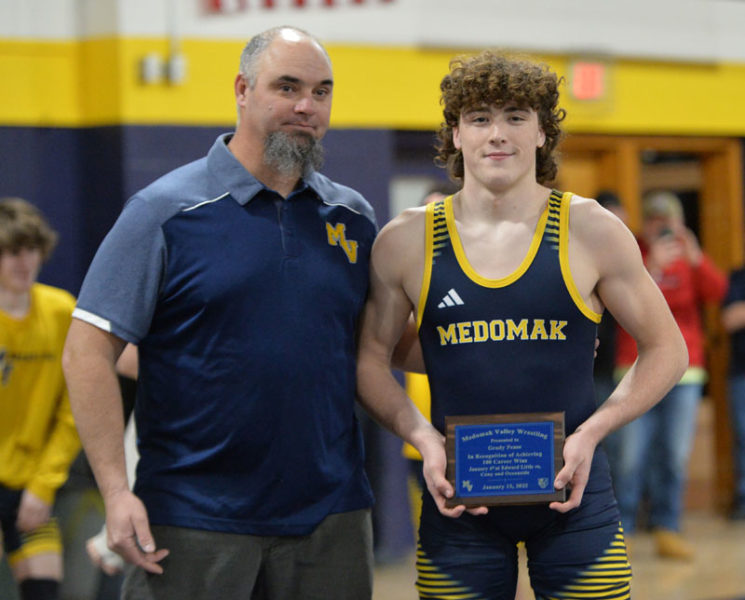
[453,104,546,190]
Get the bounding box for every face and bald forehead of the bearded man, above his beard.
[236,30,333,144]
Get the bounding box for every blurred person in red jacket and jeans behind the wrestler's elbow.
[611,191,727,560]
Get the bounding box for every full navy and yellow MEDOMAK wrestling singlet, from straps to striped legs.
[417,191,631,600]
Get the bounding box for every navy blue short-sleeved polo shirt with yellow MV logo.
[74,135,377,535]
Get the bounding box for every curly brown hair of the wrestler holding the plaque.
[435,50,566,184]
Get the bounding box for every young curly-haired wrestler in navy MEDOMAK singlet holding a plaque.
[358,51,687,600]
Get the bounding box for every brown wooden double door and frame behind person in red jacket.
[555,135,745,509]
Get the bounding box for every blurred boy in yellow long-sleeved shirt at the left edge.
[0,198,80,600]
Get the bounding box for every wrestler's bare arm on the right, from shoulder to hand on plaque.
[551,200,688,512]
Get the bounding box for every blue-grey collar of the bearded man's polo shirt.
[207,133,325,205]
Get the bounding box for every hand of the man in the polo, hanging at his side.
[104,490,168,574]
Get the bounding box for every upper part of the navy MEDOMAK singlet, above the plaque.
[418,191,600,433]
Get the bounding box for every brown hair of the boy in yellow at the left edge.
[0,198,58,260]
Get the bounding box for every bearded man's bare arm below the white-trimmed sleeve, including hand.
[62,319,168,573]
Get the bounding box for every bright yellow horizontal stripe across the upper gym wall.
[0,38,745,136]
